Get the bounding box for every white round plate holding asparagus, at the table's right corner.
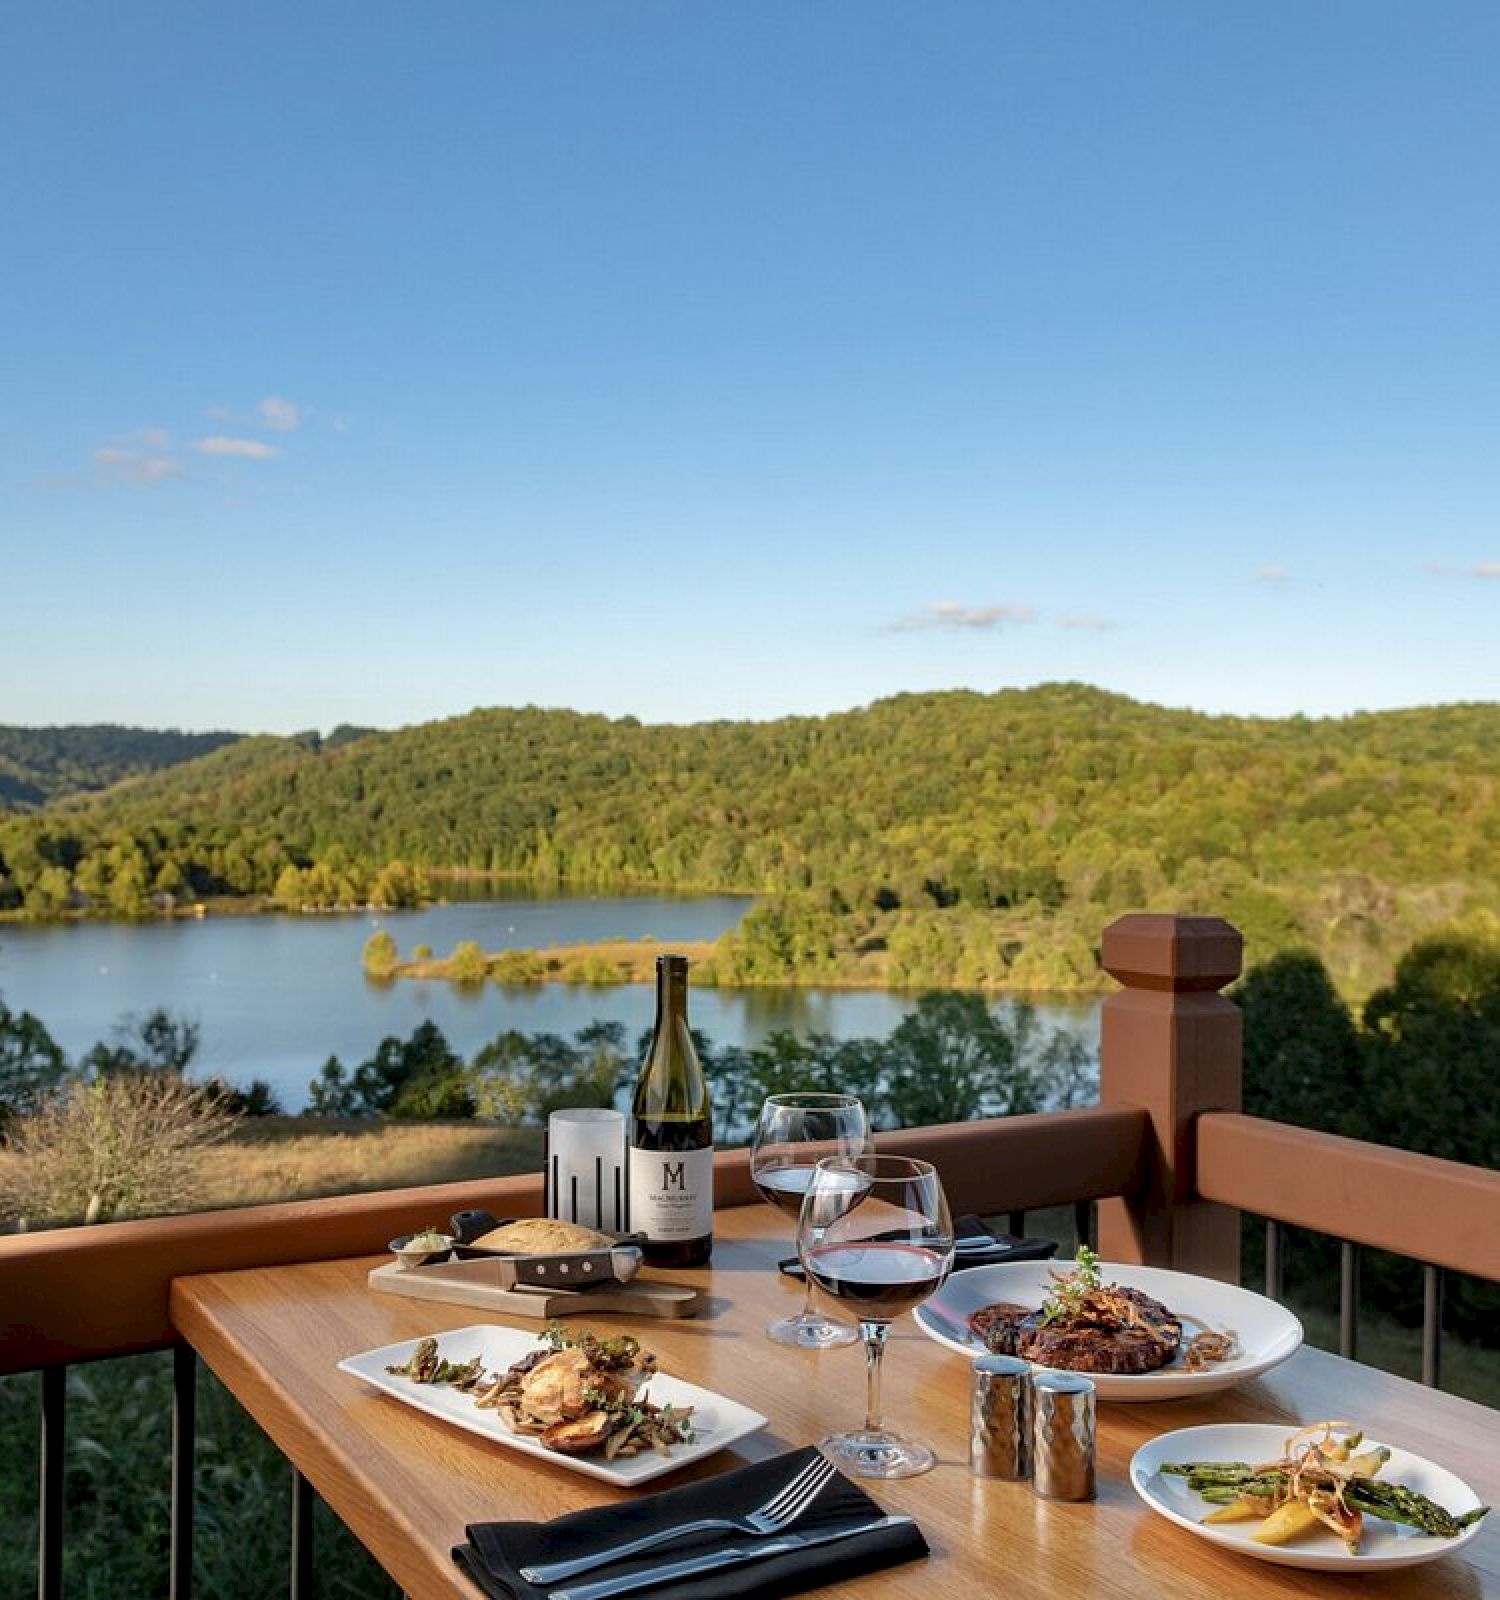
[1131,1422,1484,1573]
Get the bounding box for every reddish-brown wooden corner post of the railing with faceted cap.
[1099,914,1243,1282]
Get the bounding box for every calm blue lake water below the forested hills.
[0,896,1097,1110]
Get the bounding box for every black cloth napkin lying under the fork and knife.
[453,1446,928,1600]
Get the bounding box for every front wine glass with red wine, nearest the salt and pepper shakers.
[796,1155,953,1478]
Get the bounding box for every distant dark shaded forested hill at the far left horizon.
[0,725,240,811]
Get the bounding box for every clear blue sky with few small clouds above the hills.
[0,0,1500,731]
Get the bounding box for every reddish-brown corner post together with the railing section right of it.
[1099,917,1500,1386]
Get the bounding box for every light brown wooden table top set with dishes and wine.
[171,1206,1500,1600]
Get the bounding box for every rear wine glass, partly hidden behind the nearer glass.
[750,1094,870,1350]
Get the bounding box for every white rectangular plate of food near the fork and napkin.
[339,1323,766,1488]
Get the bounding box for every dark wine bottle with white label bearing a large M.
[628,955,713,1267]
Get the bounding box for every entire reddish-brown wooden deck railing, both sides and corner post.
[0,915,1500,1600]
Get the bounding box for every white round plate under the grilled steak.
[916,1261,1302,1400]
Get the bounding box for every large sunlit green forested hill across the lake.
[0,685,1500,987]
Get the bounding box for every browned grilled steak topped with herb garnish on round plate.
[969,1285,1182,1373]
